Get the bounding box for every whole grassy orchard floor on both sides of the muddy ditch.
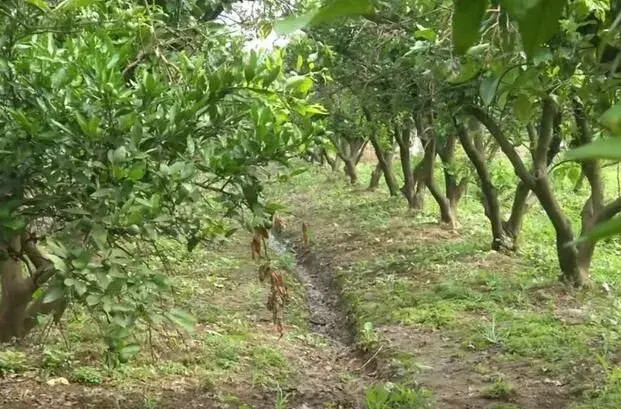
[0,158,621,409]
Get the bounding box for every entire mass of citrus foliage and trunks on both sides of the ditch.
[0,0,621,382]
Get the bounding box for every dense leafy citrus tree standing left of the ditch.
[0,0,312,356]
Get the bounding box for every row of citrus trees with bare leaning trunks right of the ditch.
[277,0,621,286]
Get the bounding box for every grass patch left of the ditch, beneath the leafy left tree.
[0,225,358,408]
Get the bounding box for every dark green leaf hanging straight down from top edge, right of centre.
[453,0,489,55]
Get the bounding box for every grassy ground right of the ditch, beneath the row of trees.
[274,161,621,408]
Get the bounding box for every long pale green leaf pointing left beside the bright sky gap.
[274,0,373,35]
